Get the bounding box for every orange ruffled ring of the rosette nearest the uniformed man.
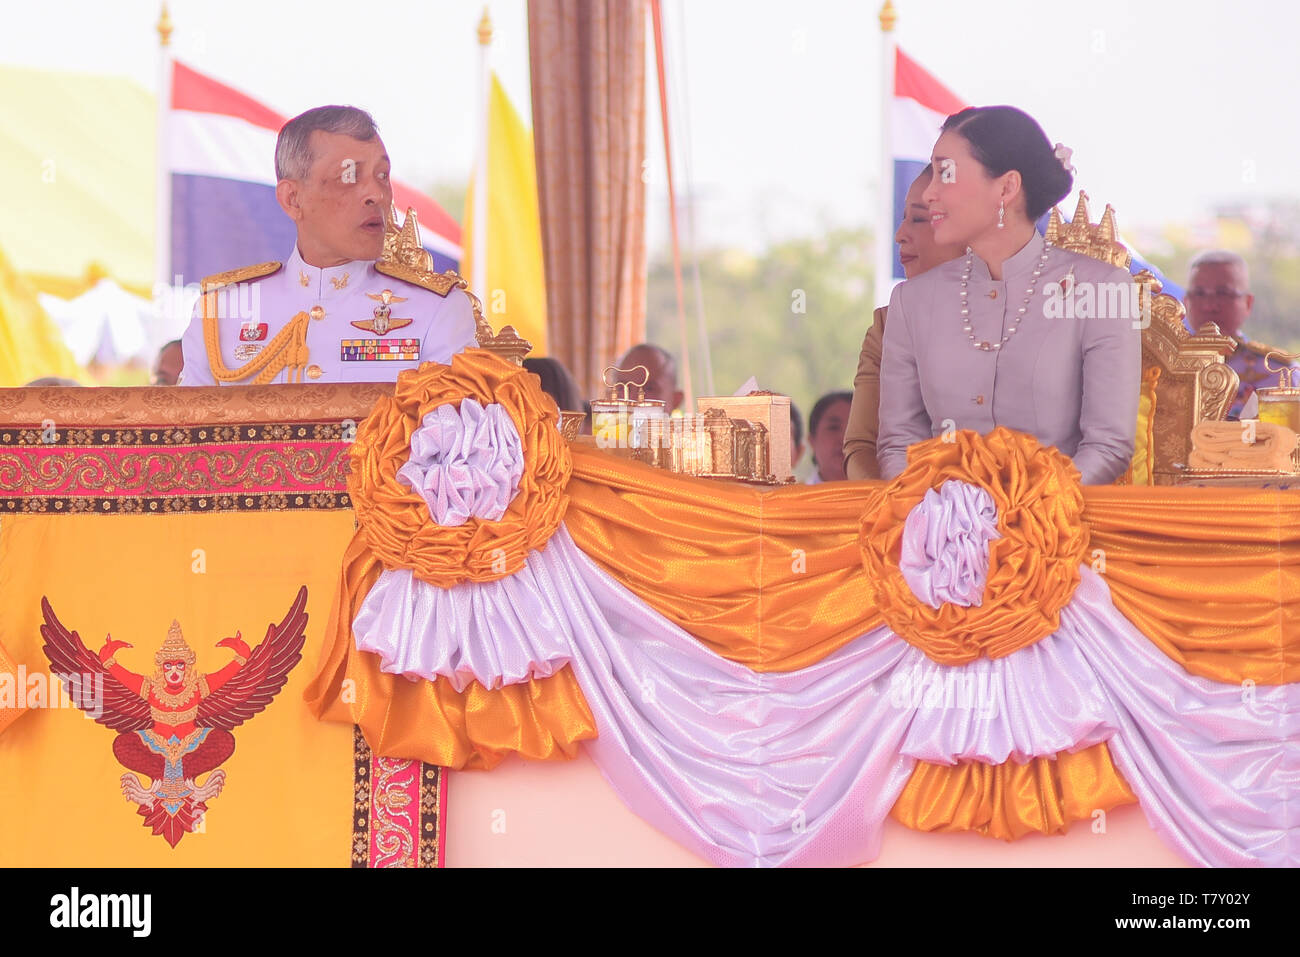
[347,348,573,588]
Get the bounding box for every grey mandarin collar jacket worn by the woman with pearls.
[878,233,1141,485]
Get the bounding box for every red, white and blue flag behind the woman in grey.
[889,47,1183,300]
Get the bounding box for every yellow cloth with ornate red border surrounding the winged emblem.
[0,386,445,867]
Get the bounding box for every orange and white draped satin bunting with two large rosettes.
[308,351,1300,865]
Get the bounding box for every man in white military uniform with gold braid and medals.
[179,107,476,385]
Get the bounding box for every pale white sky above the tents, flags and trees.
[0,0,1300,252]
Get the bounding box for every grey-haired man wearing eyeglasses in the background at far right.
[1183,250,1300,419]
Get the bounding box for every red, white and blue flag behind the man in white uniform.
[165,62,460,283]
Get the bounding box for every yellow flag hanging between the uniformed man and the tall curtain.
[460,73,546,356]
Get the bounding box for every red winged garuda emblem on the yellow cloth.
[40,586,307,848]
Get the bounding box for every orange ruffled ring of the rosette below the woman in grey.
[858,426,1088,664]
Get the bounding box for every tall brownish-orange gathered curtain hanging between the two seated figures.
[528,0,646,395]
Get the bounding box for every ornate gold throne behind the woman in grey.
[1047,197,1238,485]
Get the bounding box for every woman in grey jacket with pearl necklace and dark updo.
[878,107,1143,485]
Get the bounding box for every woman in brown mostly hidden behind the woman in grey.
[844,165,966,480]
